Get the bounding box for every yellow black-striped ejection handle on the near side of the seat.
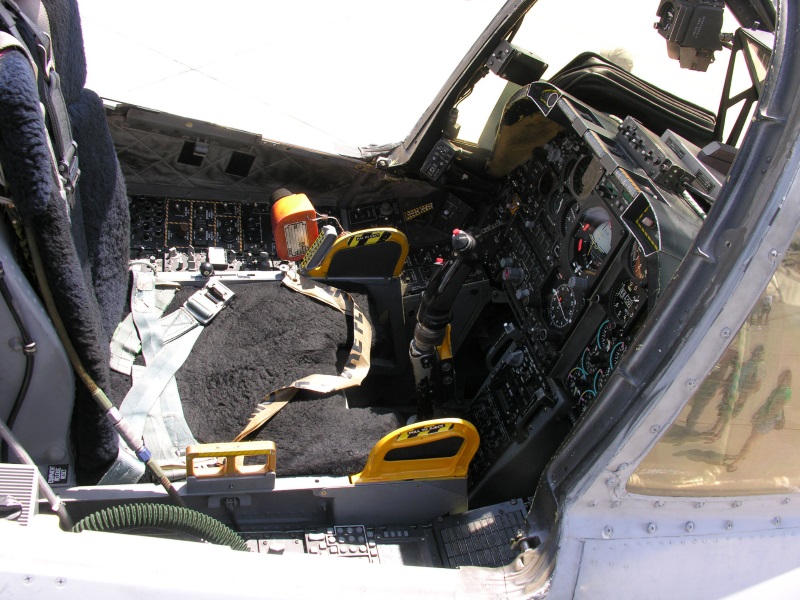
[350,418,480,483]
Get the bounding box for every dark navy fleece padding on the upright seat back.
[0,0,129,484]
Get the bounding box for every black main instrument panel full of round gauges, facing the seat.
[466,86,701,497]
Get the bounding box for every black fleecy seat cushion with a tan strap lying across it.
[109,283,404,476]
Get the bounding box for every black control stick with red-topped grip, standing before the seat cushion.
[409,229,483,420]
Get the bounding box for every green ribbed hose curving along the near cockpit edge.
[72,504,250,552]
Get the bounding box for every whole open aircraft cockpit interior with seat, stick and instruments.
[0,0,790,597]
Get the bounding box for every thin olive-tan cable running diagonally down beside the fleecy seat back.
[25,225,186,508]
